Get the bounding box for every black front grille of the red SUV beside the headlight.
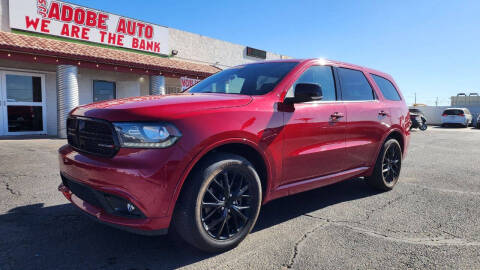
[67,117,118,157]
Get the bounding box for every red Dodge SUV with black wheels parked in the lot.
[59,59,410,252]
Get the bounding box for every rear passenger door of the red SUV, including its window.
[337,68,391,169]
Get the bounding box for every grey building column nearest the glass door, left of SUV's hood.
[57,65,79,138]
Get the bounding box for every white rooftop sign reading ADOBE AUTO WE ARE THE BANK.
[10,0,169,54]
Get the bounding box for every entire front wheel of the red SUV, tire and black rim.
[172,153,262,253]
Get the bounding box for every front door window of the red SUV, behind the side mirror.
[287,66,337,101]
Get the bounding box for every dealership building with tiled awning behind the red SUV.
[0,0,287,137]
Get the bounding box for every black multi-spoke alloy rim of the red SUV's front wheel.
[201,169,254,240]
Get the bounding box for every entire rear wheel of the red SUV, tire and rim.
[367,139,402,191]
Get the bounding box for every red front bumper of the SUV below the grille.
[59,145,188,235]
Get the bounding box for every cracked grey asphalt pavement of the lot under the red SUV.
[0,127,480,270]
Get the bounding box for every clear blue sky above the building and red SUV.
[68,0,480,105]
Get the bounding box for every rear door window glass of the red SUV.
[338,68,375,100]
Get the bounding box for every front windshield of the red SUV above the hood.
[187,62,298,96]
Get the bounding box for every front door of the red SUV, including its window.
[282,66,346,183]
